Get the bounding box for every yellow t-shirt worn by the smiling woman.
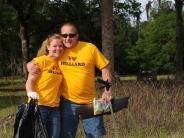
[33,55,63,107]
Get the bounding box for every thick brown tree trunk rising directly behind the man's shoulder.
[101,0,114,72]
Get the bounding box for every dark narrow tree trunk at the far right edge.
[175,0,184,81]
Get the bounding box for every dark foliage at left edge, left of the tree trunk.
[0,6,21,76]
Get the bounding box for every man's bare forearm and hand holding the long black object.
[102,67,112,102]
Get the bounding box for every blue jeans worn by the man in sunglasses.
[60,97,106,138]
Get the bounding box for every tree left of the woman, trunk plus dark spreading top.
[7,0,45,77]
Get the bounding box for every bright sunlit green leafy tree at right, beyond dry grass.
[128,10,176,73]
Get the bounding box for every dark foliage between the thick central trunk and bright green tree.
[114,0,141,74]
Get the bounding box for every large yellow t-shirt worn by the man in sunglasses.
[59,41,109,104]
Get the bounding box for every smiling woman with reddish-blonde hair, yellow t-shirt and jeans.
[26,34,63,138]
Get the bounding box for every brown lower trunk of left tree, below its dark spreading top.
[19,21,29,79]
